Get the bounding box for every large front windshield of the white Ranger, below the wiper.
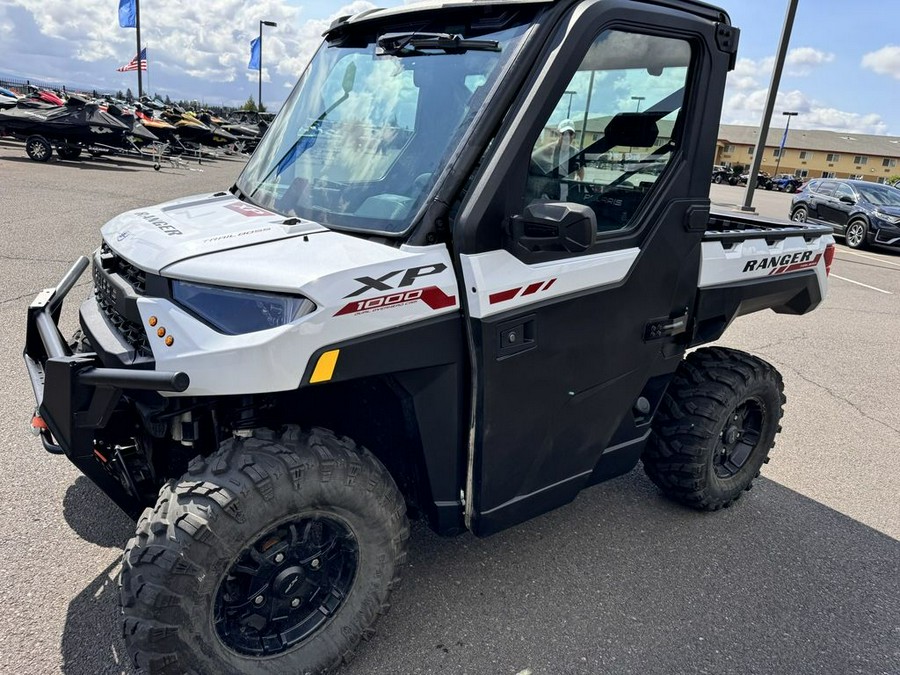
[237,12,531,234]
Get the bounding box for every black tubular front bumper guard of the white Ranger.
[24,256,190,514]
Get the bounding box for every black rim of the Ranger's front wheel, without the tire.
[213,516,359,656]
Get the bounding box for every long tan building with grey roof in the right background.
[715,124,900,183]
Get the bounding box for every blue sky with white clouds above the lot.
[0,0,900,136]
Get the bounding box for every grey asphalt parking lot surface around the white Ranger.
[0,145,900,675]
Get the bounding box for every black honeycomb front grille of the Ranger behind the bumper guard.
[94,242,153,357]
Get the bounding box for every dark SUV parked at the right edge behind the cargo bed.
[791,178,900,248]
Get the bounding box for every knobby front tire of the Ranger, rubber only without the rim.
[119,427,409,675]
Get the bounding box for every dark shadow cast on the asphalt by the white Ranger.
[62,471,900,675]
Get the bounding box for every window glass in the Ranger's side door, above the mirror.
[525,30,691,238]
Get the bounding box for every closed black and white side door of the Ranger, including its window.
[454,2,736,534]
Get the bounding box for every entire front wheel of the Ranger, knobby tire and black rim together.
[119,427,409,675]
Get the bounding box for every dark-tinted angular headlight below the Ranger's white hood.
[172,281,316,335]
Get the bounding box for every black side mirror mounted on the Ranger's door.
[510,202,597,253]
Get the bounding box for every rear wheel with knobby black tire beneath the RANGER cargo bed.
[642,347,785,511]
